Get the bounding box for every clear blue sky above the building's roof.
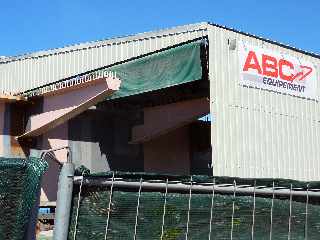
[0,0,320,56]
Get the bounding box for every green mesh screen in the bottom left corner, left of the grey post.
[0,158,47,240]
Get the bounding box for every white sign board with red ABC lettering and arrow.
[239,41,317,99]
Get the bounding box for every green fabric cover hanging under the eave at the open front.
[108,42,202,99]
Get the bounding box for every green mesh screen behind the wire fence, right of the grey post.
[69,173,320,240]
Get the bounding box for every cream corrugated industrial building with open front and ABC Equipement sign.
[0,23,320,202]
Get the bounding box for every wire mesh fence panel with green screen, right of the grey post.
[69,173,320,240]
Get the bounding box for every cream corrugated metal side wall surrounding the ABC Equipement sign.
[208,26,320,180]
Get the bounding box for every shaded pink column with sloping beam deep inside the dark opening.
[138,98,210,174]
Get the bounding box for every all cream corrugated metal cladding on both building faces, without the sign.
[0,23,320,180]
